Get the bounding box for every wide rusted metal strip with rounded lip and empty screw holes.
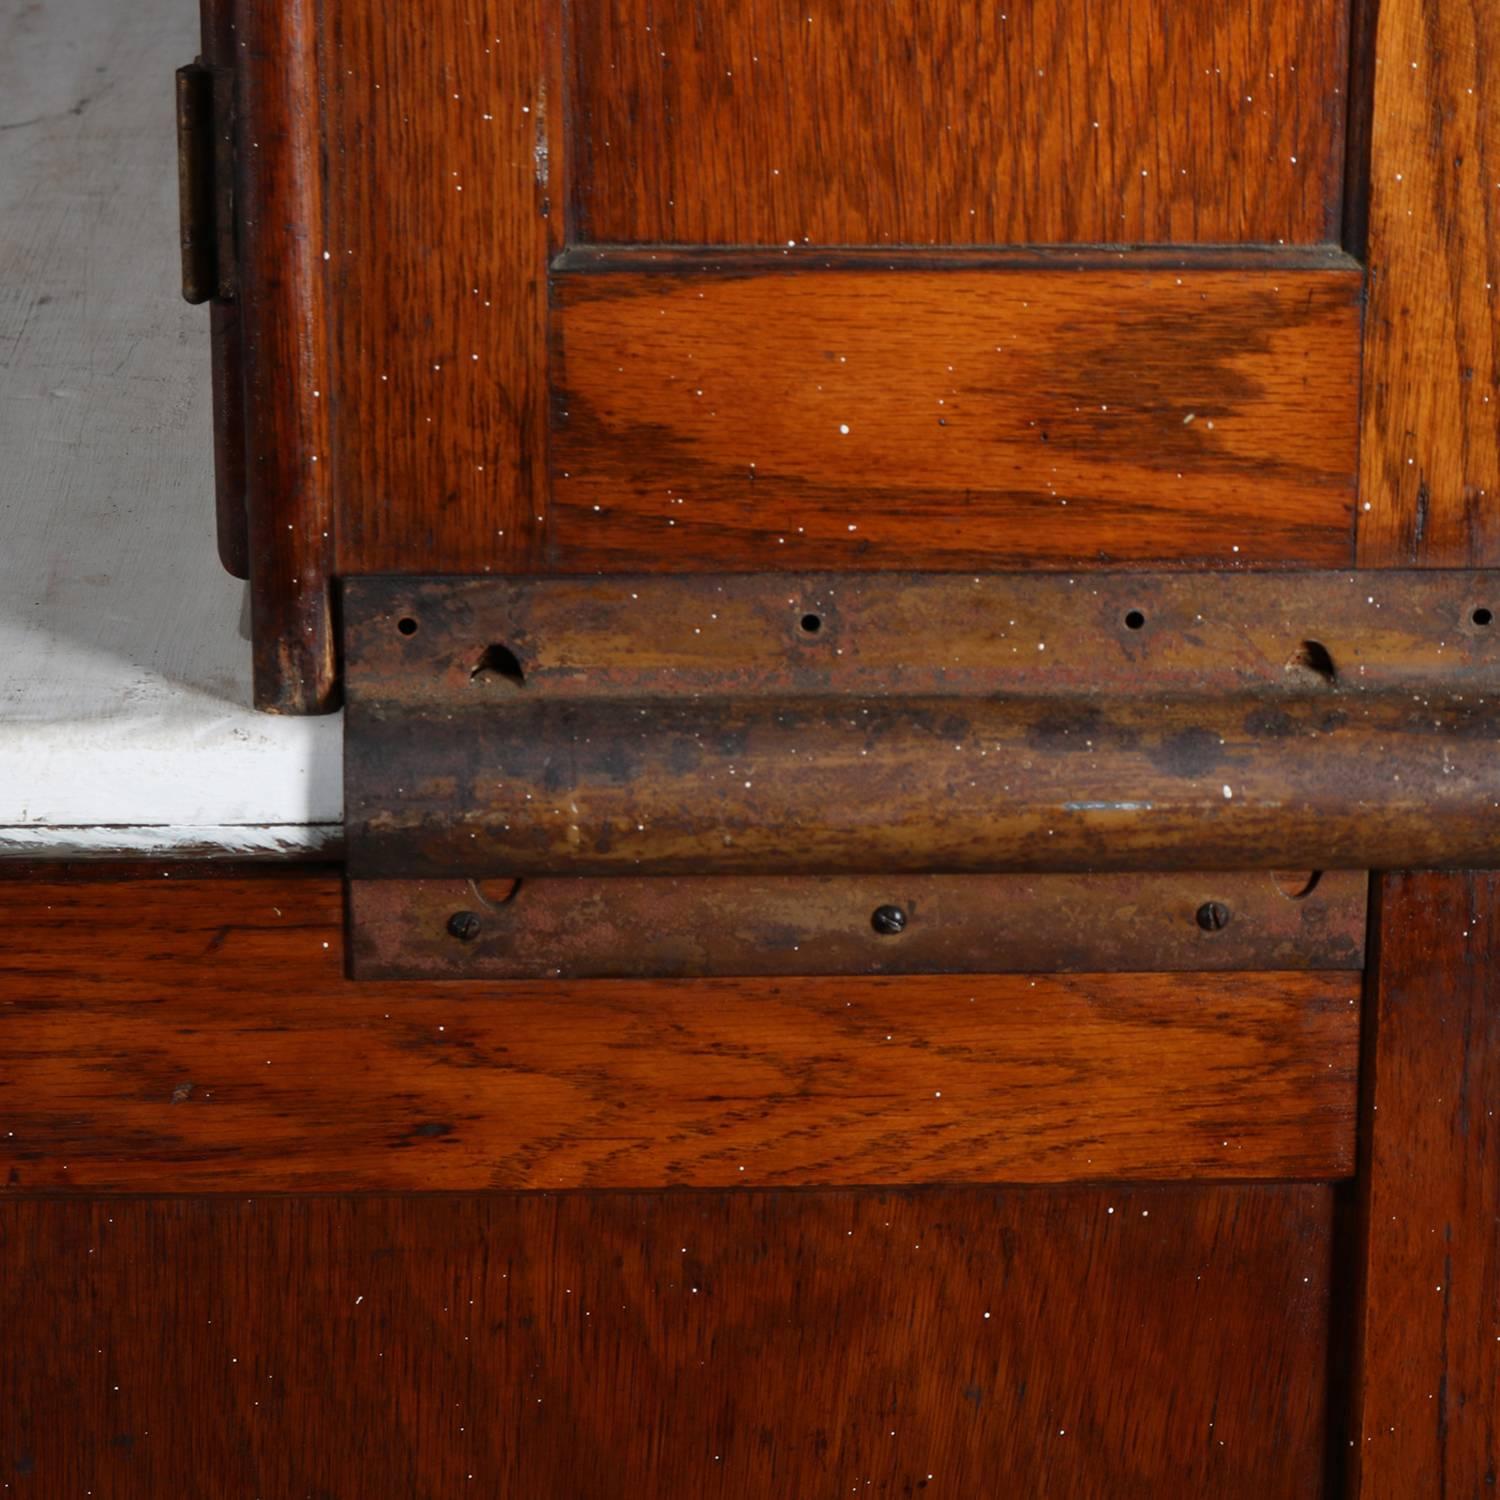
[345,572,1500,879]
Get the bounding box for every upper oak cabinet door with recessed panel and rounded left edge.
[230,0,1365,711]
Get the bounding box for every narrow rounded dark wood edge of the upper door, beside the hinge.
[236,0,338,713]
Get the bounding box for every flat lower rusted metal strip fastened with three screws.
[350,872,1367,980]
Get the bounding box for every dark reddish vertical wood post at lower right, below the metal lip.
[1352,875,1500,1500]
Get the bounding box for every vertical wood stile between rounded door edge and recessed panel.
[326,0,564,573]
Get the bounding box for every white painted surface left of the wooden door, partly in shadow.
[0,0,342,854]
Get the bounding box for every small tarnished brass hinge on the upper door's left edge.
[177,62,236,305]
